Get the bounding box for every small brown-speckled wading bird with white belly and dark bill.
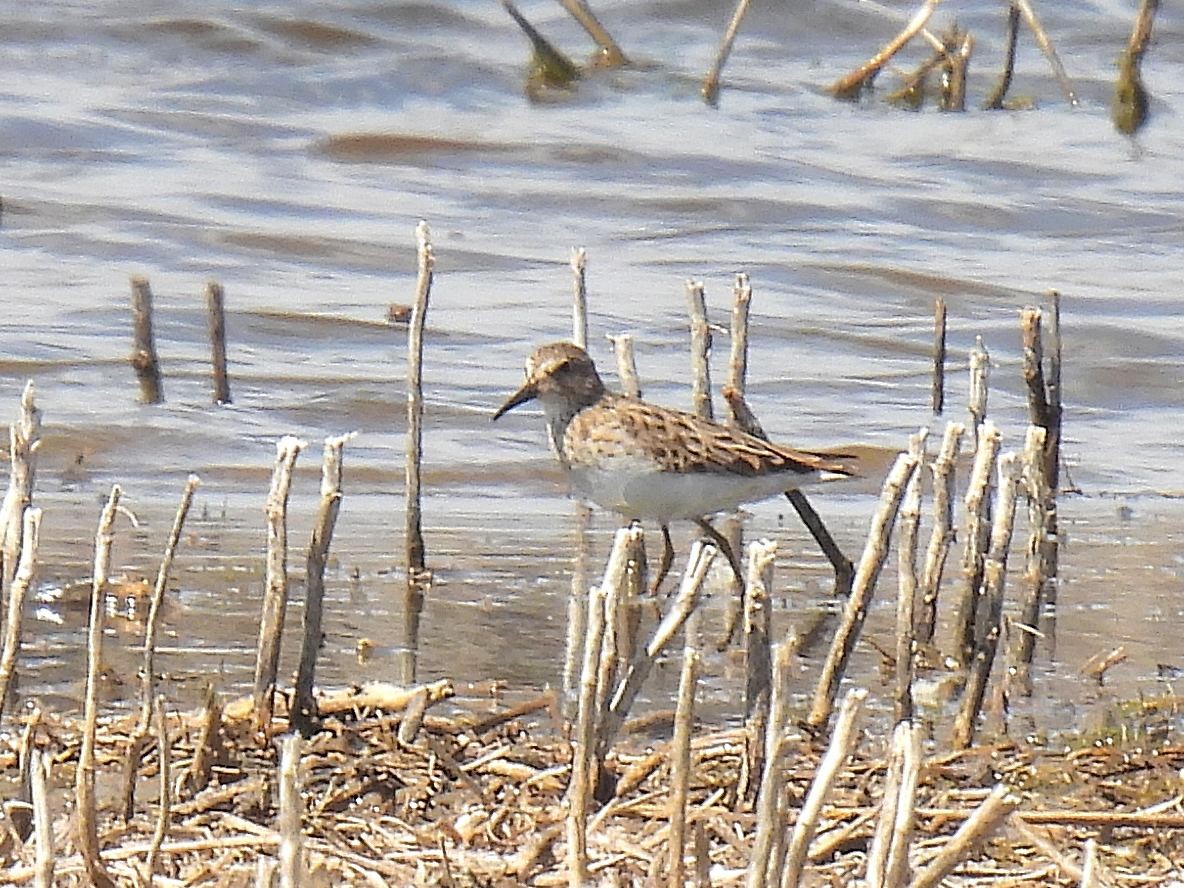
[494,342,855,591]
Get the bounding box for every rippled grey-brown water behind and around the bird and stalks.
[0,0,1184,725]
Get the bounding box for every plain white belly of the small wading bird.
[571,461,817,523]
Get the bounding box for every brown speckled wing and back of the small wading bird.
[564,395,855,477]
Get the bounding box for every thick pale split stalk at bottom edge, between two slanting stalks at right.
[867,720,921,888]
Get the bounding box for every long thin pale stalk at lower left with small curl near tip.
[75,484,123,888]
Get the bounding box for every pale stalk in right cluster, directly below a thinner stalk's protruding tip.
[951,420,1002,663]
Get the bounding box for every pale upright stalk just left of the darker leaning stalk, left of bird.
[251,435,305,735]
